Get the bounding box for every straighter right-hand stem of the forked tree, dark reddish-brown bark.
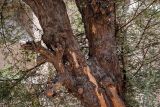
[76,0,122,92]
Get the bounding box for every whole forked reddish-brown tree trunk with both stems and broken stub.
[23,0,125,107]
